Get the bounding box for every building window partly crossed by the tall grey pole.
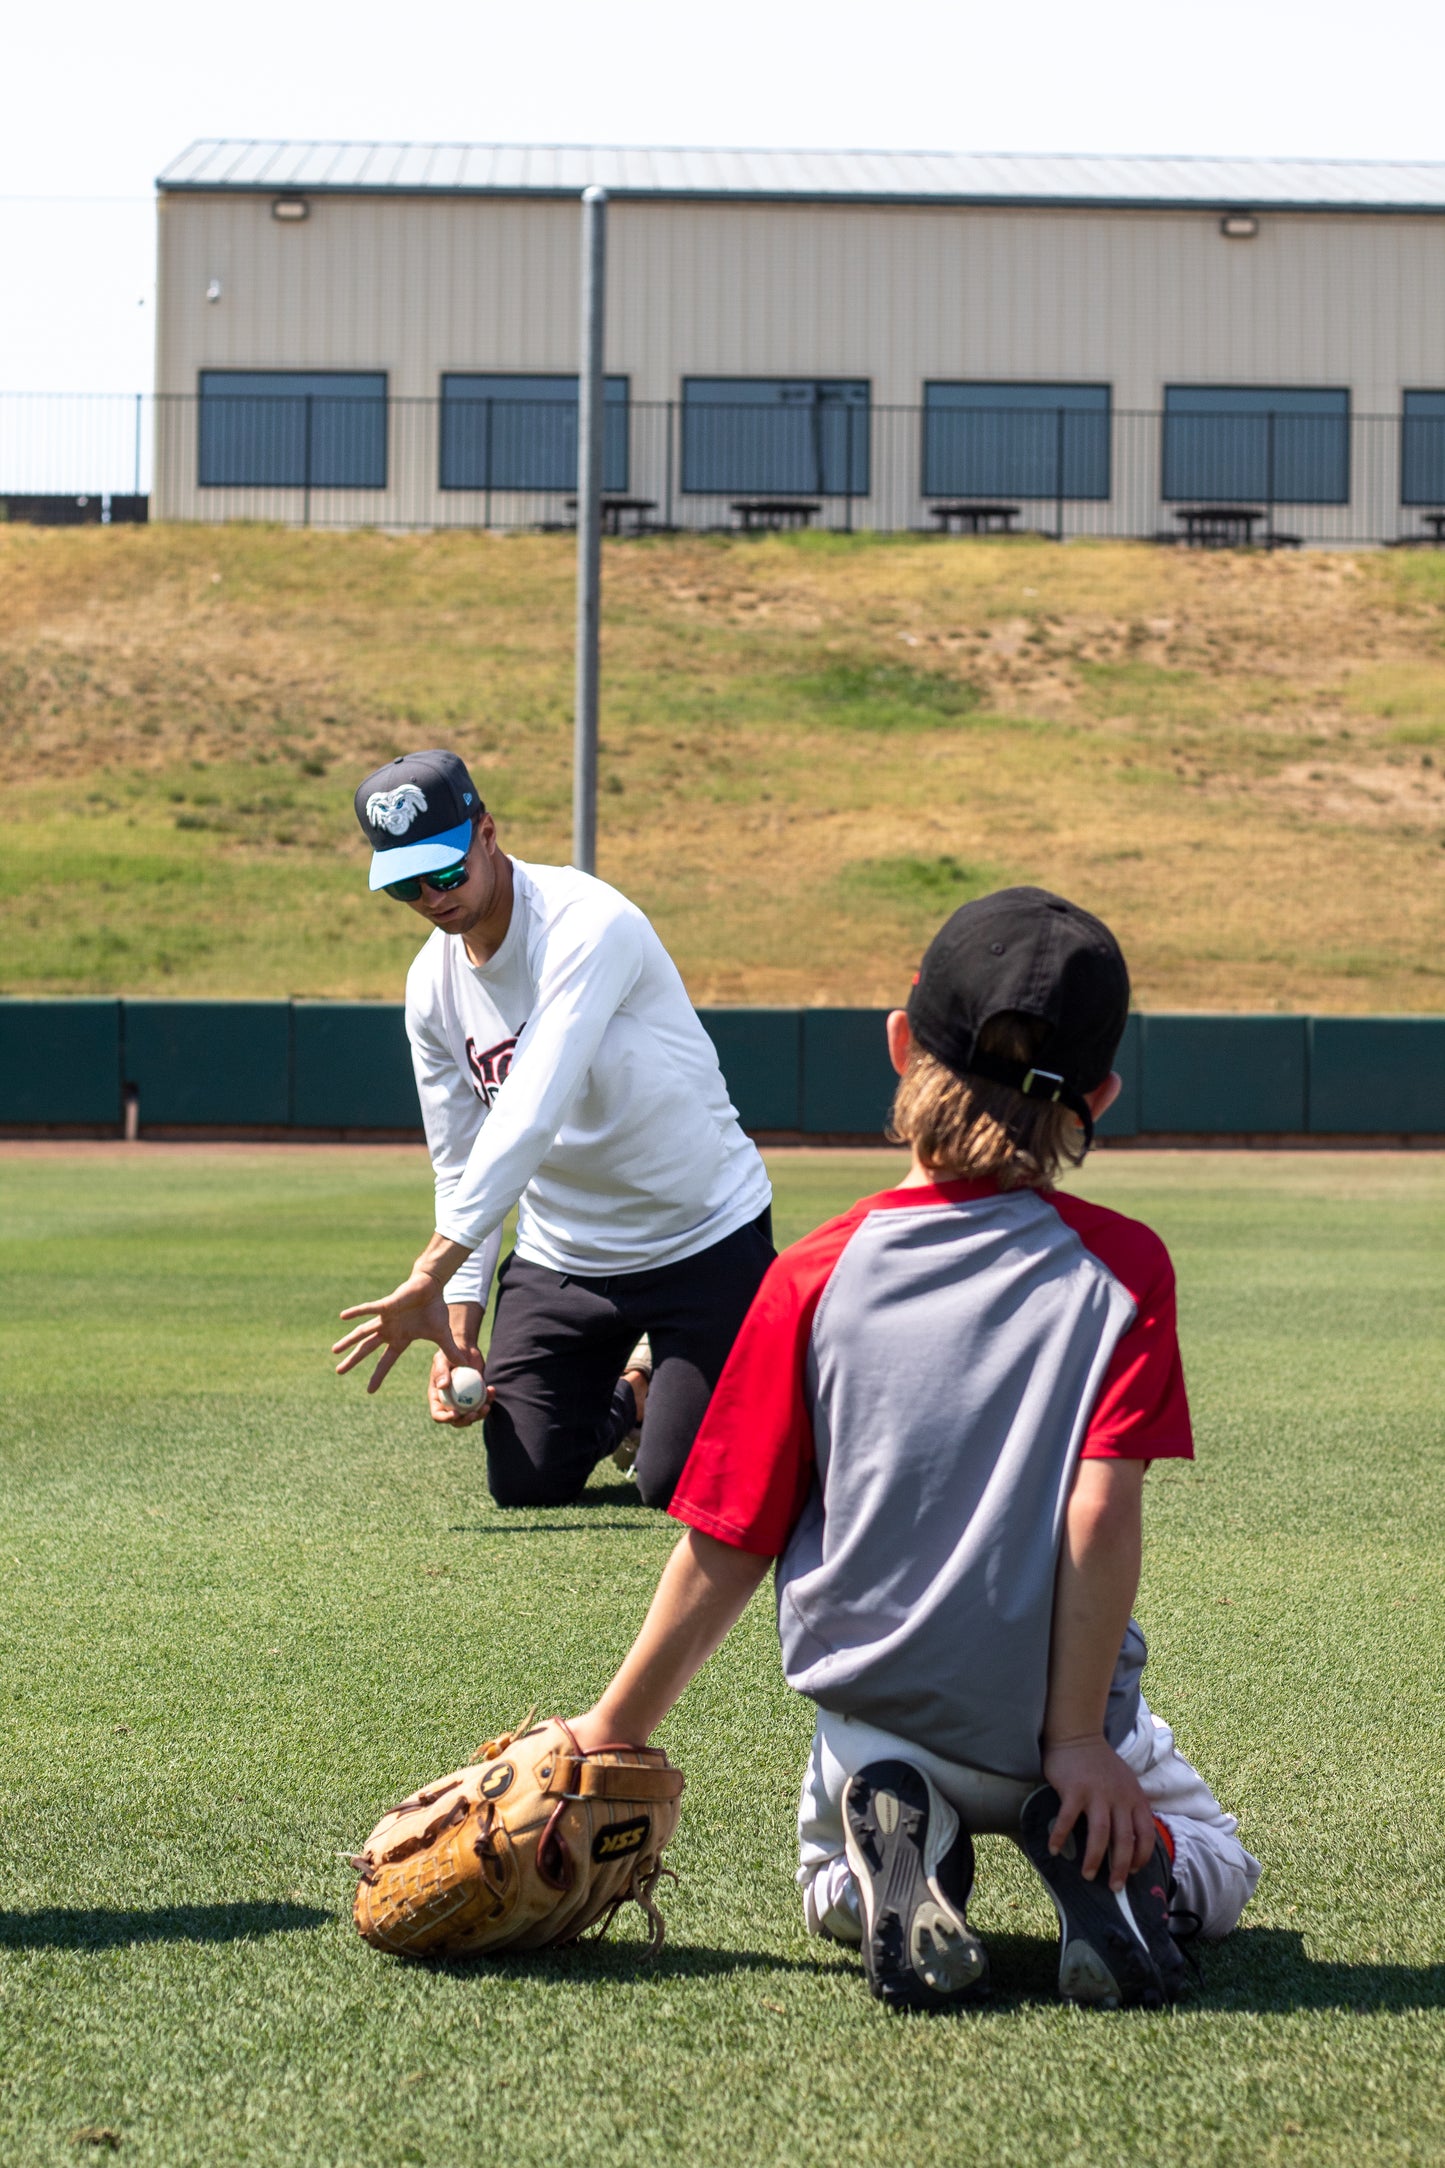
[442,375,628,490]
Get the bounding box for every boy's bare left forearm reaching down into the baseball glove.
[572,1528,773,1750]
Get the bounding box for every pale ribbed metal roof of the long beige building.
[156,139,1445,210]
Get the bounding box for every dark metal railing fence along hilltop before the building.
[0,398,1445,546]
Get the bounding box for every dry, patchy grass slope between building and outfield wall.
[0,527,1445,1010]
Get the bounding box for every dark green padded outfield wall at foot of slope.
[0,999,1445,1138]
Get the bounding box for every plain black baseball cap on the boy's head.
[908,889,1129,1138]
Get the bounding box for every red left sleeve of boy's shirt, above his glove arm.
[669,1199,869,1559]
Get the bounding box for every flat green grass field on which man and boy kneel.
[0,1147,1445,2168]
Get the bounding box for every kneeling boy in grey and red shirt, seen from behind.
[574,889,1259,2008]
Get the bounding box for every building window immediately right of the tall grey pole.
[682,377,869,496]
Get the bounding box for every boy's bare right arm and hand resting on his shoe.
[1044,1459,1157,1890]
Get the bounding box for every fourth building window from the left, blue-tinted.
[923,384,1109,499]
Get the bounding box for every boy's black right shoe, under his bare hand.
[1018,1784,1185,2010]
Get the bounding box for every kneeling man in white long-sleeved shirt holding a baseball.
[334,748,773,1507]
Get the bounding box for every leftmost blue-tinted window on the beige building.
[197,369,386,490]
